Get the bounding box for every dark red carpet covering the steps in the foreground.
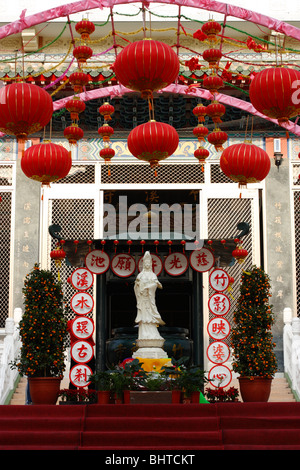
[0,403,300,451]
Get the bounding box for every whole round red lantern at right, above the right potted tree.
[220,143,271,186]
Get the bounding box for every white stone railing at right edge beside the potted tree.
[283,308,300,401]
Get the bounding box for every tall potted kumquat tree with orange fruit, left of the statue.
[11,264,68,404]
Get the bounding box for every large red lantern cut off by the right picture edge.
[249,67,300,125]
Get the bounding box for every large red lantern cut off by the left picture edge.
[0,83,53,141]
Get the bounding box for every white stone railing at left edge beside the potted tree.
[0,312,21,405]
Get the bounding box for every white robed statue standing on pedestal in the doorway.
[133,251,167,358]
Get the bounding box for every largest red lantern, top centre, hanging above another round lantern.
[113,39,179,98]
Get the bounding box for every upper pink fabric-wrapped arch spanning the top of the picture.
[0,0,300,40]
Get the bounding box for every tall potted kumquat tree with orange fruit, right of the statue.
[231,266,277,401]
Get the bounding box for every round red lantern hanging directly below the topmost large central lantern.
[127,121,179,174]
